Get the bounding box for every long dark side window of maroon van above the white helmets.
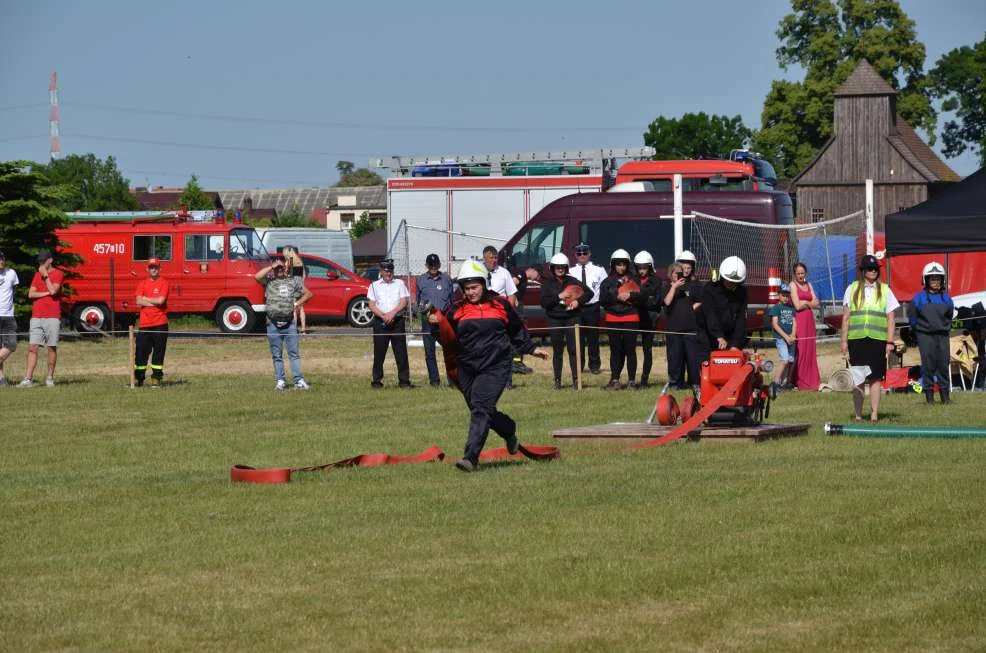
[579,218,692,273]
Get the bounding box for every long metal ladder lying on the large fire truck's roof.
[370,147,656,177]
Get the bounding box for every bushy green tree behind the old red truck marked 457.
[37,154,139,211]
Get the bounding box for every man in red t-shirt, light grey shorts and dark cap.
[20,250,65,388]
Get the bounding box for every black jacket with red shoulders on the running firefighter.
[445,292,535,372]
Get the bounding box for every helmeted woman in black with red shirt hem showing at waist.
[599,249,640,390]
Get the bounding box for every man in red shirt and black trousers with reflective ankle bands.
[134,258,168,388]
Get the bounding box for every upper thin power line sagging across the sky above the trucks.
[61,102,641,132]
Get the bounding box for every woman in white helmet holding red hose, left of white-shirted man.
[541,252,592,390]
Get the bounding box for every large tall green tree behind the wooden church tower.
[754,0,937,177]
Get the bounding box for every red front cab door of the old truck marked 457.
[180,232,226,313]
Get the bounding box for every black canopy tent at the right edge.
[884,168,986,256]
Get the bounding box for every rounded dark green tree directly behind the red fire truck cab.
[644,112,751,160]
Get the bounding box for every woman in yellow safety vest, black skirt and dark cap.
[842,254,900,422]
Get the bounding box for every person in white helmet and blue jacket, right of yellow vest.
[910,261,955,404]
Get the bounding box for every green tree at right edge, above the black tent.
[929,33,986,167]
